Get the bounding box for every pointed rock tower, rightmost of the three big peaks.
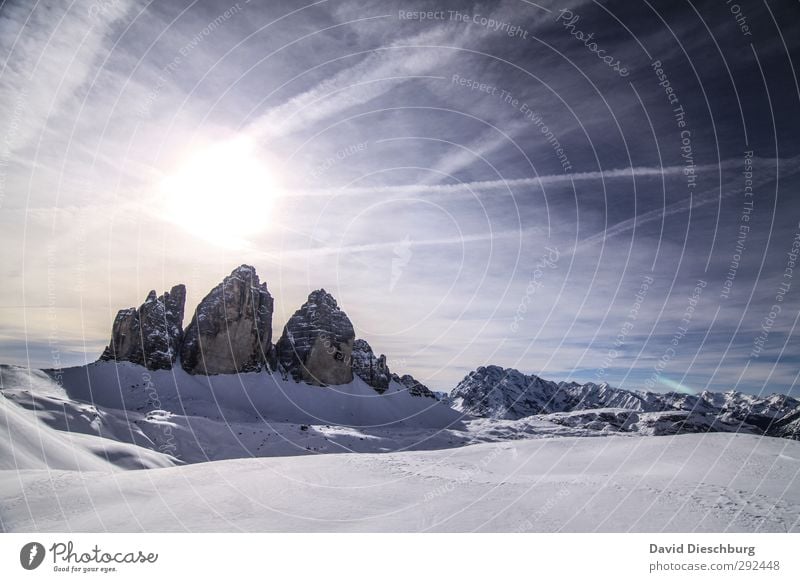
[275,289,355,386]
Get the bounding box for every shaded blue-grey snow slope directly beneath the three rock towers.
[56,362,463,428]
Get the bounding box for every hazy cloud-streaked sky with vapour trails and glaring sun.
[0,0,800,396]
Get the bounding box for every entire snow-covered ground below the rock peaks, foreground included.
[0,362,800,532]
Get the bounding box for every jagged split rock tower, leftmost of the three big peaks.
[100,285,186,370]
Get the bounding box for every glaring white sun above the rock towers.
[159,138,278,247]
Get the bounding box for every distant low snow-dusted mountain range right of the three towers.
[448,366,800,439]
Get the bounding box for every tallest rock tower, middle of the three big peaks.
[181,265,274,375]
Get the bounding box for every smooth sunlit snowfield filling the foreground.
[0,433,800,532]
